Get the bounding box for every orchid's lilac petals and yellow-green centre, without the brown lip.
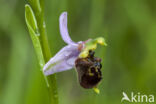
[43,12,106,92]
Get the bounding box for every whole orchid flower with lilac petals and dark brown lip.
[43,12,106,92]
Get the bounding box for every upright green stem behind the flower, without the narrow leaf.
[28,0,58,104]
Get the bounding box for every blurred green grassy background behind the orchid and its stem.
[0,0,156,104]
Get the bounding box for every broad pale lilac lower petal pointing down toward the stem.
[43,45,80,75]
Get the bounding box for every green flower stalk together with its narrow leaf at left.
[25,0,58,104]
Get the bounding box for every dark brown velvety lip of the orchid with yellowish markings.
[75,50,102,89]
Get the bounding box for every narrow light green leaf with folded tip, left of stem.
[25,4,45,68]
